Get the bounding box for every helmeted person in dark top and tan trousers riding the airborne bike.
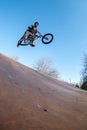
[17,22,39,47]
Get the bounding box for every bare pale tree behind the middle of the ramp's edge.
[34,58,58,78]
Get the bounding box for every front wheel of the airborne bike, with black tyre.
[41,33,53,44]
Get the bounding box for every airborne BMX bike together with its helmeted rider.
[17,22,53,47]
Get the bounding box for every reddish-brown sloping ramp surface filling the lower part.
[0,54,87,130]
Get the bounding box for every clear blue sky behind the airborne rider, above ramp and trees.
[0,0,87,82]
